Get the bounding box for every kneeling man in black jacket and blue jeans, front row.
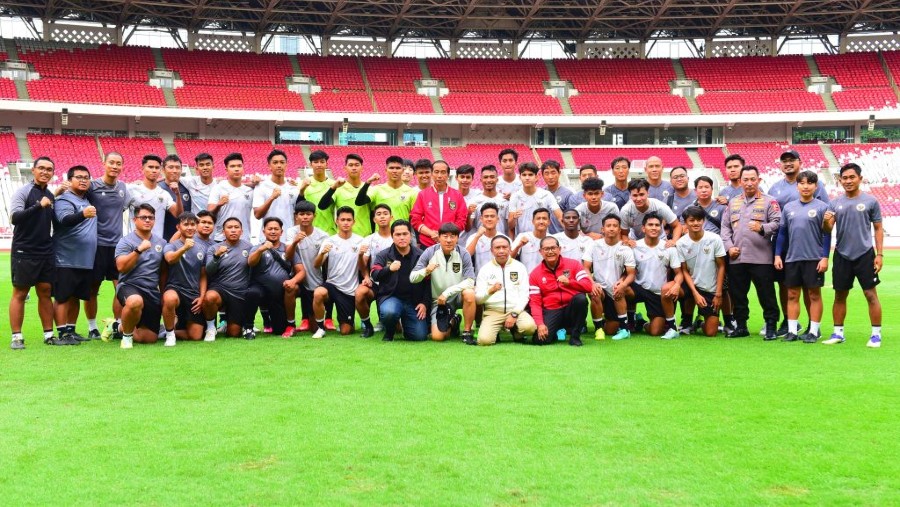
[372,220,431,342]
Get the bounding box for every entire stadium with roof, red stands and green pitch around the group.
[0,0,900,505]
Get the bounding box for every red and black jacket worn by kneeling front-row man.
[528,257,594,326]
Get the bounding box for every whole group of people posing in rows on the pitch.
[9,144,883,349]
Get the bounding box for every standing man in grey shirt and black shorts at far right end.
[824,163,884,348]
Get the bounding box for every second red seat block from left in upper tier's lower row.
[174,85,305,111]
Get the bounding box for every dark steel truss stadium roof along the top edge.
[0,0,900,41]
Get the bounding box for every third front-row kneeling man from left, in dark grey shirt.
[203,217,256,342]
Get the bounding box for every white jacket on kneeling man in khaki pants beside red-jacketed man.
[475,257,529,313]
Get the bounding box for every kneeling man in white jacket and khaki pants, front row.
[475,234,537,345]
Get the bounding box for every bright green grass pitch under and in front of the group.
[0,252,900,506]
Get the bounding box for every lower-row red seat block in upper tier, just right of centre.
[441,91,562,115]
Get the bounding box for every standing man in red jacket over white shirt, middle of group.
[409,160,469,249]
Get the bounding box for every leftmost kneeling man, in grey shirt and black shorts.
[116,203,166,349]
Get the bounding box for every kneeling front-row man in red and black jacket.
[528,236,592,347]
